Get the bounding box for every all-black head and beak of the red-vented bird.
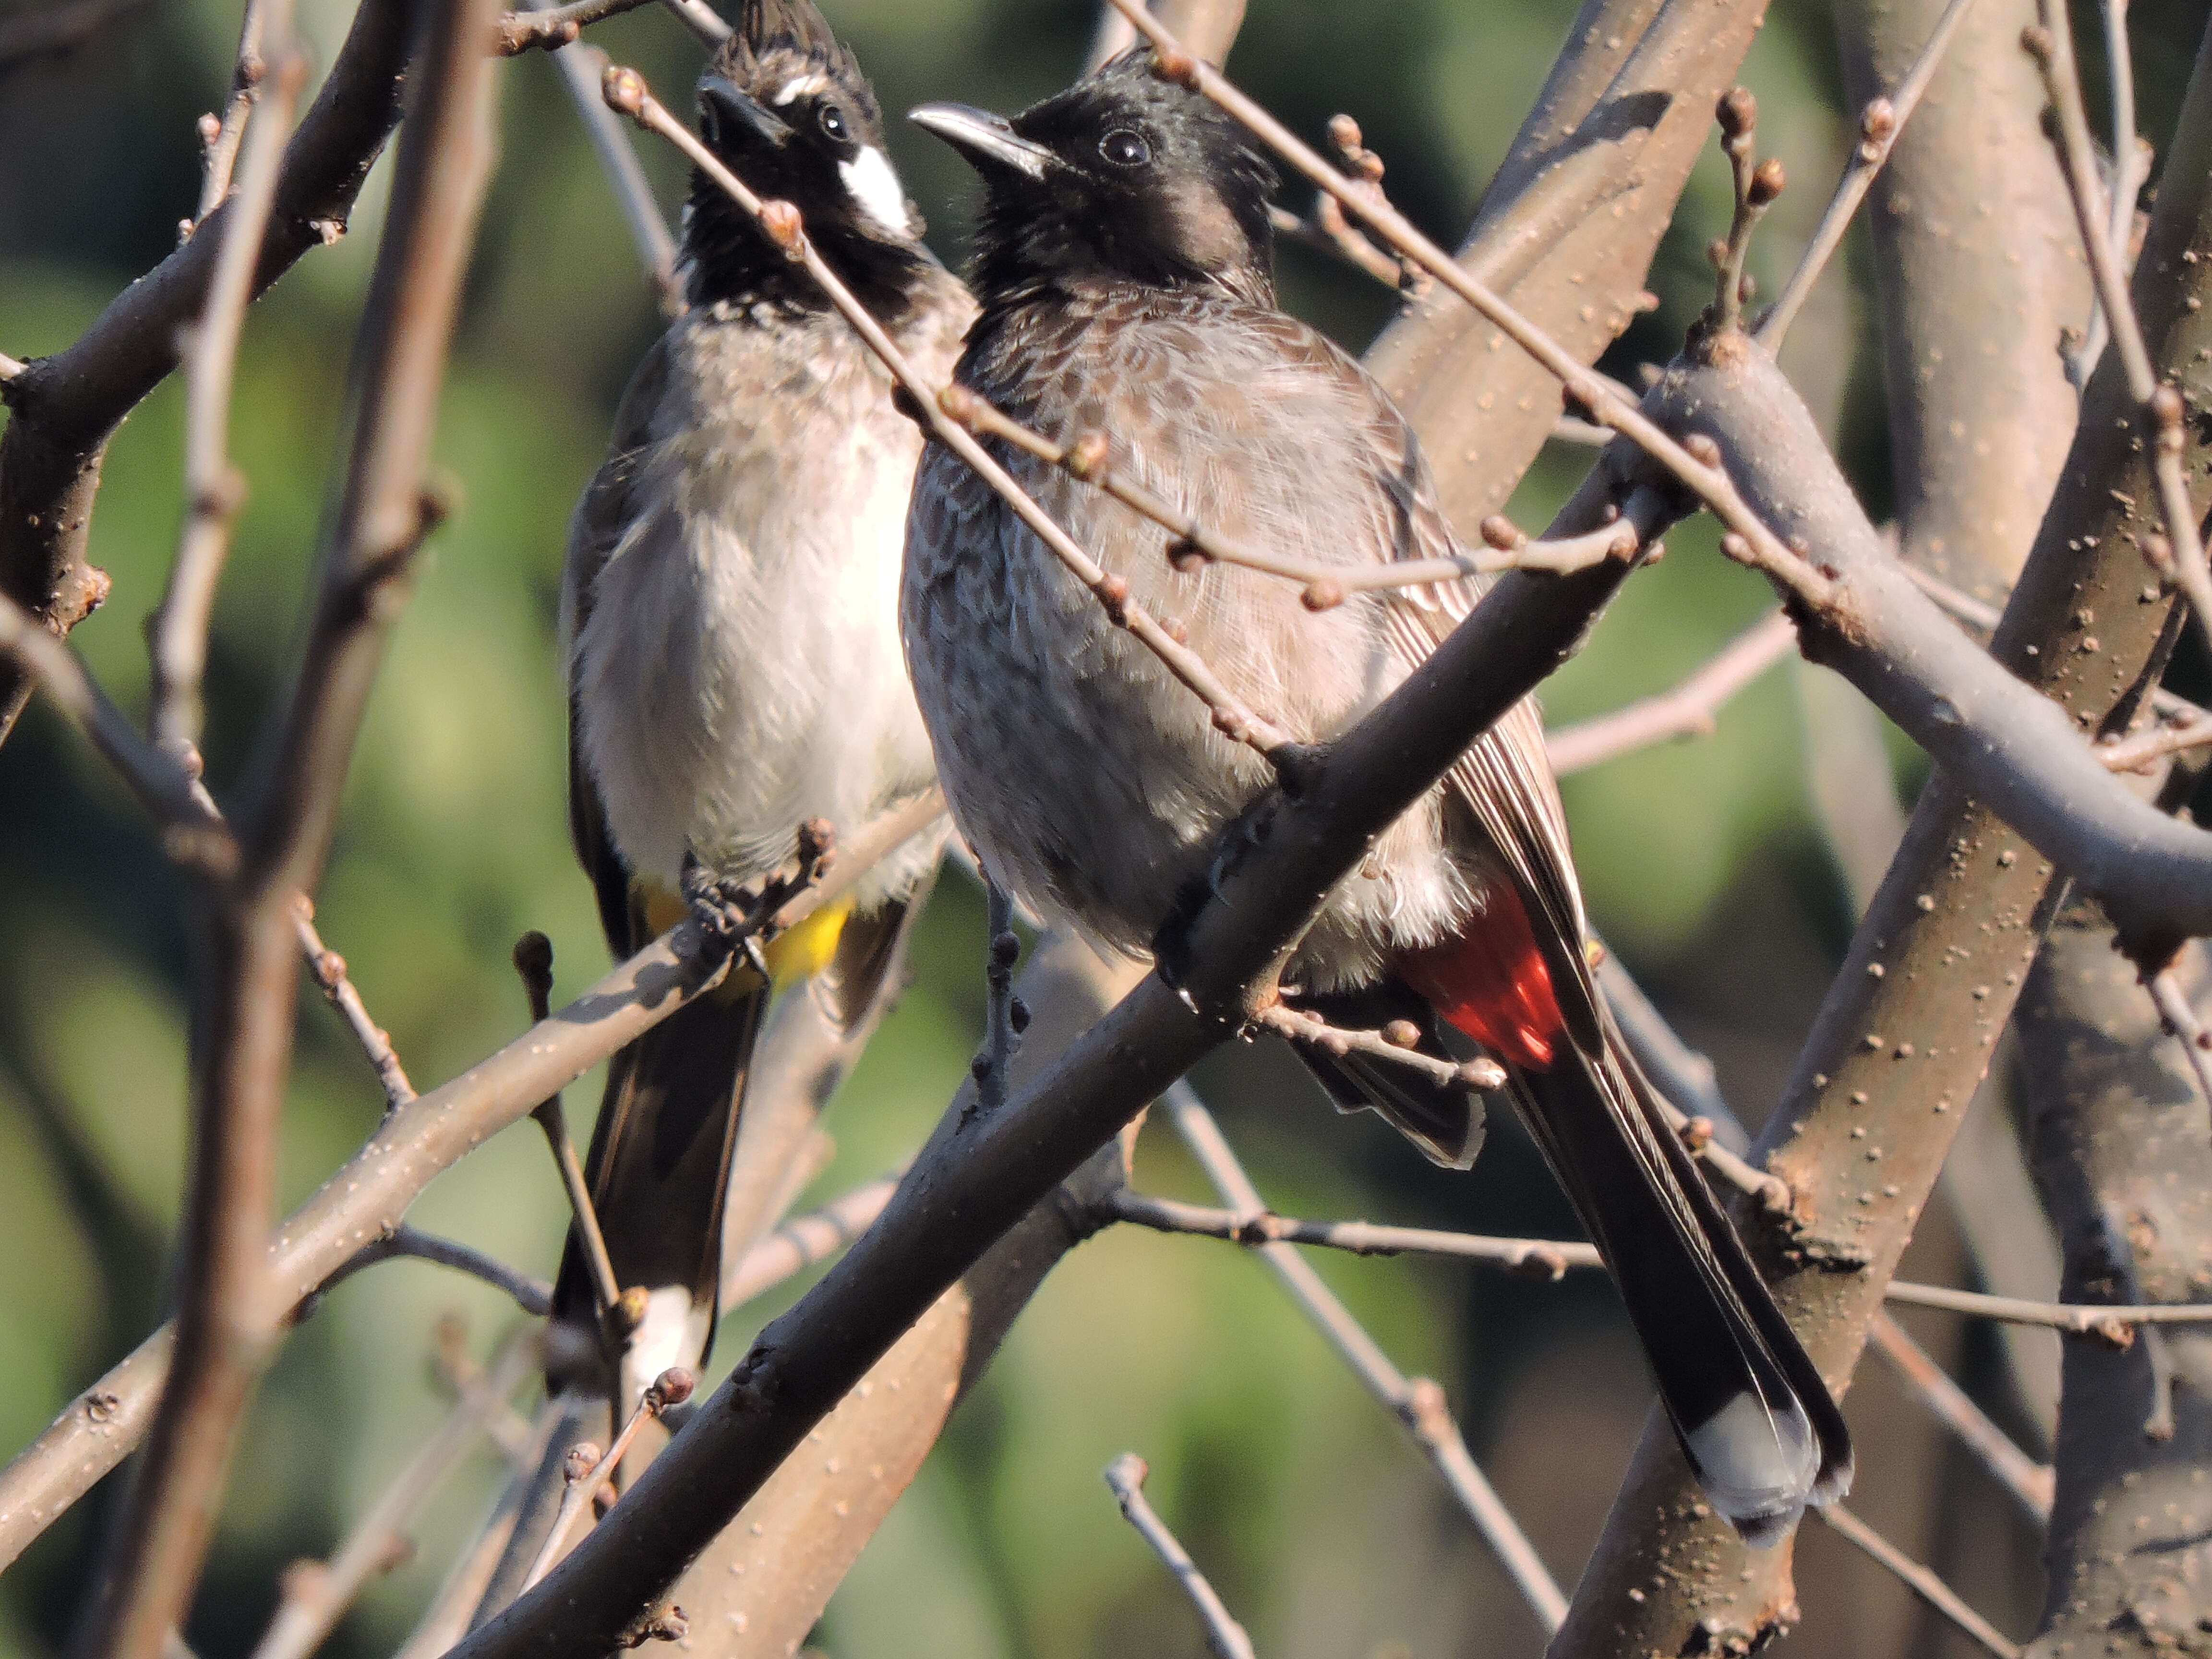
[914,47,1276,305]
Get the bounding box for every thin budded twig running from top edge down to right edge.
[2020,0,2212,668]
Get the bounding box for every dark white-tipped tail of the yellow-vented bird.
[553,986,770,1396]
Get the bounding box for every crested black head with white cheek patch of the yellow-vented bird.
[684,0,927,314]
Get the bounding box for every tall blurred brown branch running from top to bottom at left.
[95,0,495,1659]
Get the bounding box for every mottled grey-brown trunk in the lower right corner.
[2020,925,2212,1659]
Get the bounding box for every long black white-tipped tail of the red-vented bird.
[1513,1020,1851,1544]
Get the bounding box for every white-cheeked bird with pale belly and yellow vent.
[555,0,975,1402]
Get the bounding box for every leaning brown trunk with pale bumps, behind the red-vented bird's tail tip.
[1553,29,2212,1655]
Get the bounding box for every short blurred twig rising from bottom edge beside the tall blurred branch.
[252,1327,540,1659]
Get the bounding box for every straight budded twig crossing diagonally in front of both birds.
[604,66,1292,768]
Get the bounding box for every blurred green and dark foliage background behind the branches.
[0,0,2194,1659]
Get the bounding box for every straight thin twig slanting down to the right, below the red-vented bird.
[1139,1083,1566,1633]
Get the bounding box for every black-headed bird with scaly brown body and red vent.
[900,51,1851,1539]
